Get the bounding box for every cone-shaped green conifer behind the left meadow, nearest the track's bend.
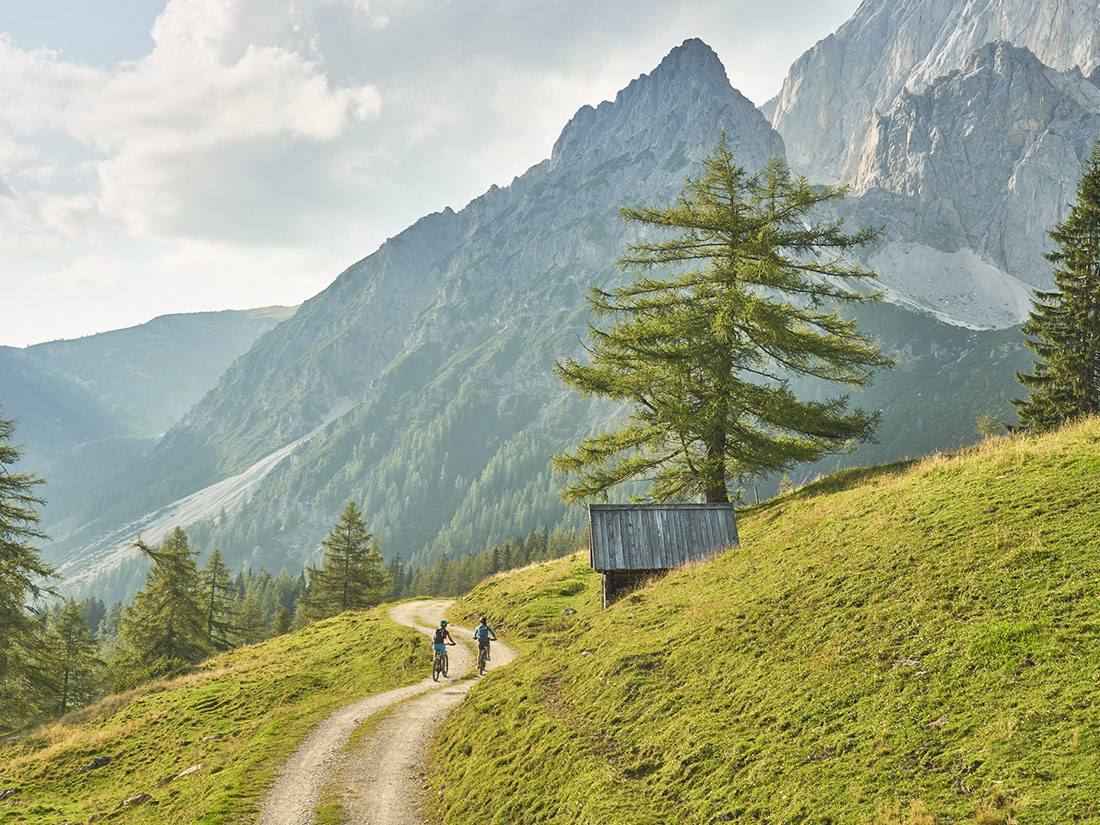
[303,502,389,619]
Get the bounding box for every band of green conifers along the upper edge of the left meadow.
[0,429,582,730]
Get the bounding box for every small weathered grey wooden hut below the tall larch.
[589,504,738,607]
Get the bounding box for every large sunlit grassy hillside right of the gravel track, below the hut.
[435,420,1100,825]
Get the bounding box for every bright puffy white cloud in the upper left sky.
[0,0,382,243]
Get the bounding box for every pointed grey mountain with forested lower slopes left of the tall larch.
[55,41,782,594]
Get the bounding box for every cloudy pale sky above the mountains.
[0,0,858,347]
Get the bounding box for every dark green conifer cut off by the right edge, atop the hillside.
[1012,141,1100,430]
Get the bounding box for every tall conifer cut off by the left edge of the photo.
[0,410,54,729]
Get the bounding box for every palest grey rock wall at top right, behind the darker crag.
[765,0,1100,180]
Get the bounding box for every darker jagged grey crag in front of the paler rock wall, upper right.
[851,43,1100,326]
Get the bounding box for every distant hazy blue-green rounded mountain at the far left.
[0,307,294,535]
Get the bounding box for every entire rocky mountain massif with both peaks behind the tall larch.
[48,0,1100,595]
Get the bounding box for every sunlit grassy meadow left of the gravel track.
[0,611,420,825]
